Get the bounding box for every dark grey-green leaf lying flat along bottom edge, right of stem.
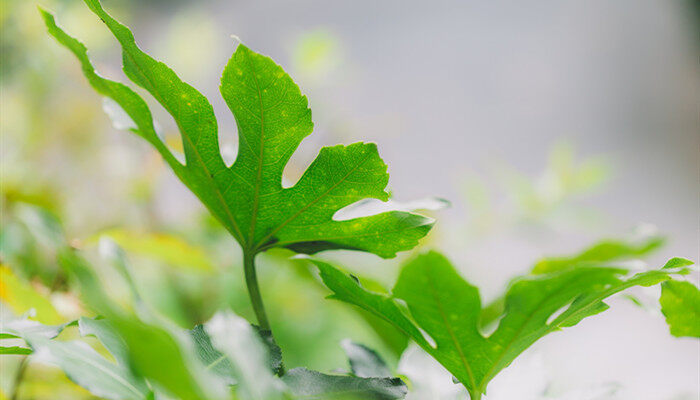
[282,368,407,400]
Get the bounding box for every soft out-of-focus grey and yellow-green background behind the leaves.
[0,0,700,400]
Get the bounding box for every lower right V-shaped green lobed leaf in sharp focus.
[312,252,685,398]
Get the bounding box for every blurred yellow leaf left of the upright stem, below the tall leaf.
[101,229,215,271]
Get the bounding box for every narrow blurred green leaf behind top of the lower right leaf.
[532,236,664,274]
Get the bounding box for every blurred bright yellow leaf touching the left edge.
[0,265,64,324]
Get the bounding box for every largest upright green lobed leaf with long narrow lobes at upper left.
[43,0,433,257]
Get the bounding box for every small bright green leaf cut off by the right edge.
[659,280,700,338]
